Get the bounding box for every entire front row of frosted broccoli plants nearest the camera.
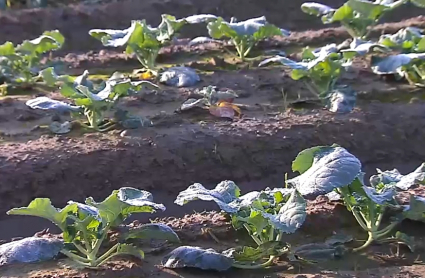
[4,145,425,271]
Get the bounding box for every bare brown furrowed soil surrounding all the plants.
[0,0,425,278]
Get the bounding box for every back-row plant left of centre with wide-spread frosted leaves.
[89,14,216,75]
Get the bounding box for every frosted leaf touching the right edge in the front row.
[370,163,425,190]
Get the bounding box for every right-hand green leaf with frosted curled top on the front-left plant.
[86,187,165,226]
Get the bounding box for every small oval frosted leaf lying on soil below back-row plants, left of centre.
[159,67,201,87]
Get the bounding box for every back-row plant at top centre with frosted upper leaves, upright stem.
[207,16,289,60]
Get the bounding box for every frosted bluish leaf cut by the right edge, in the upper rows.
[371,53,425,76]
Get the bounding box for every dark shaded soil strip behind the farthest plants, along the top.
[0,0,423,51]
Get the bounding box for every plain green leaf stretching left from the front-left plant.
[7,198,78,231]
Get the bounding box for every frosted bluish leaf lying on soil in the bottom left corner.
[0,237,63,266]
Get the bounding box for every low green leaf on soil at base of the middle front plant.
[232,241,289,262]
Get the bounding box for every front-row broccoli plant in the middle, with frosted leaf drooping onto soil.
[163,181,306,270]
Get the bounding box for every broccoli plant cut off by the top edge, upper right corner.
[301,0,425,39]
